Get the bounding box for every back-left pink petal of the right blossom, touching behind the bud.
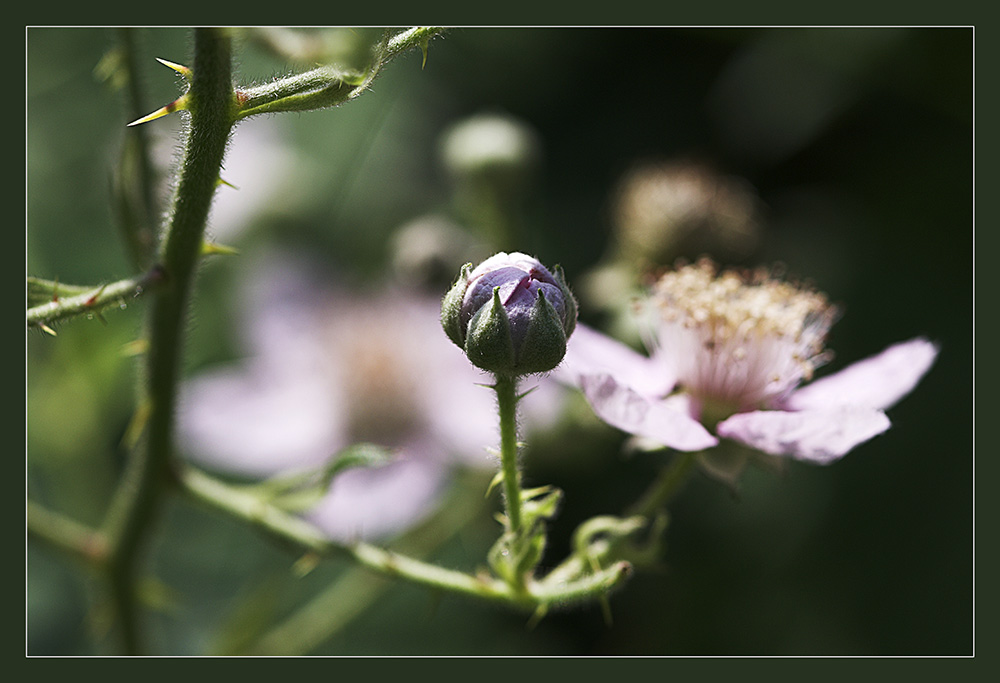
[552,324,677,397]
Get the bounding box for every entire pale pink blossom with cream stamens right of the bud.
[557,260,937,464]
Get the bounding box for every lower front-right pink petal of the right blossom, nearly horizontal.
[716,406,889,465]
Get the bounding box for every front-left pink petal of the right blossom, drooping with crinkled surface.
[580,374,718,451]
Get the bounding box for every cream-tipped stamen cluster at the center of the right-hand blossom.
[646,259,837,412]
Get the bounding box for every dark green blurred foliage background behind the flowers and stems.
[26,28,974,655]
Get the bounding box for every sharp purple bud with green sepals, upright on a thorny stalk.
[441,252,576,376]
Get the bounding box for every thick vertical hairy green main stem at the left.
[105,29,235,653]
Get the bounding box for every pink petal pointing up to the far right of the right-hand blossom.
[783,338,938,410]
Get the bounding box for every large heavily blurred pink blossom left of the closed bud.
[179,250,551,539]
